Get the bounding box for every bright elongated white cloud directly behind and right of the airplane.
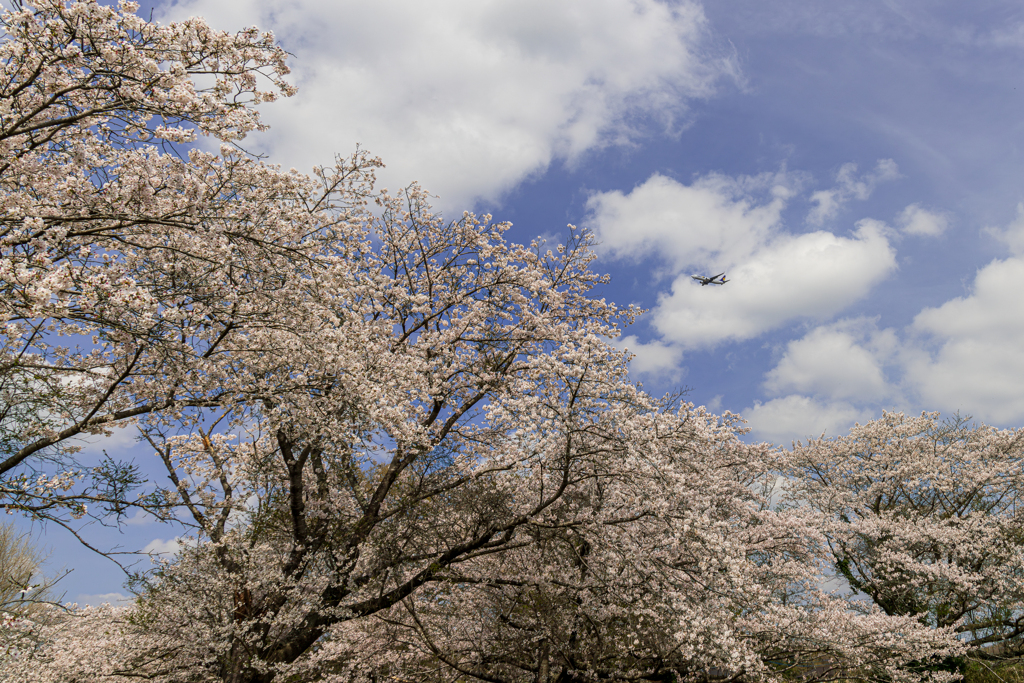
[653,220,896,348]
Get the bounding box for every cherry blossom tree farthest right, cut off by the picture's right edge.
[792,413,1024,656]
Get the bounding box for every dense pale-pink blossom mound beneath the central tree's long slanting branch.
[315,407,955,683]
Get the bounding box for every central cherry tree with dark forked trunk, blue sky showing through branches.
[114,189,663,680]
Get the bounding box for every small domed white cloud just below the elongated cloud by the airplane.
[764,318,899,401]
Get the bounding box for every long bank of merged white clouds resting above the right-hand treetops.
[744,232,1024,430]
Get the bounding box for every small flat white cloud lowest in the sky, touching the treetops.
[742,394,871,444]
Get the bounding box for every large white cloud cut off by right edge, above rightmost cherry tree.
[907,258,1024,424]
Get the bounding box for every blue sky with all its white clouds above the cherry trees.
[19,0,1024,601]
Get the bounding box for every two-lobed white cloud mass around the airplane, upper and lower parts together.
[588,172,896,349]
